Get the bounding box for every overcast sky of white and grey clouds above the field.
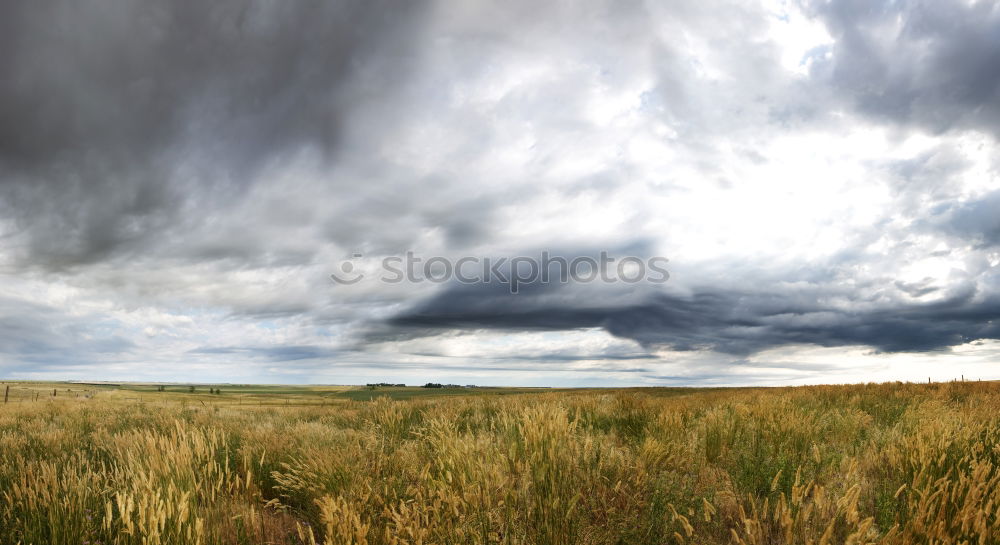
[0,0,1000,386]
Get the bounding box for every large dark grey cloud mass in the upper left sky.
[0,0,424,269]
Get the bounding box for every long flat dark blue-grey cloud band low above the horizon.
[380,266,1000,355]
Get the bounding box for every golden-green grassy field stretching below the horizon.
[0,382,1000,545]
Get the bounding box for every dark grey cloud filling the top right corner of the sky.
[809,0,1000,136]
